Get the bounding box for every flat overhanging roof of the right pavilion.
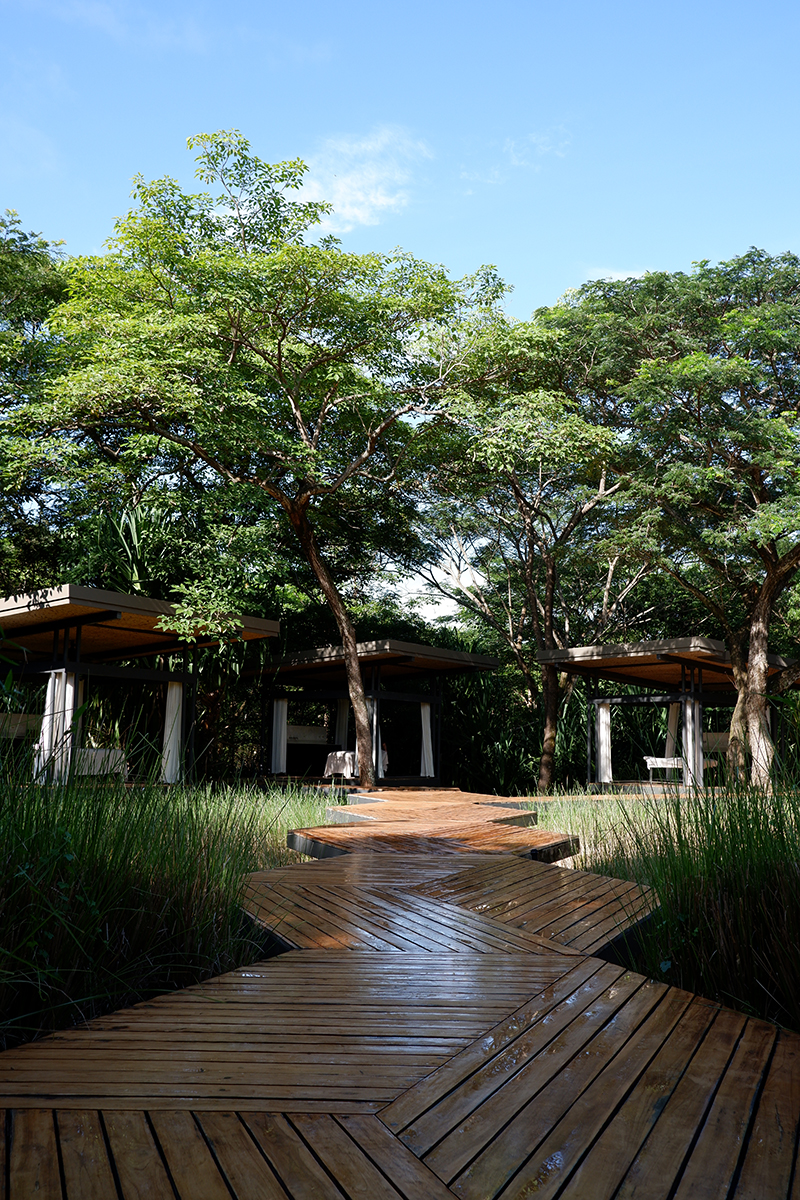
[537,637,789,691]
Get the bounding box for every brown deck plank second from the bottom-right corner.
[675,1021,777,1200]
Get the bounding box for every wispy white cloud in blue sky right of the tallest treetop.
[302,126,433,233]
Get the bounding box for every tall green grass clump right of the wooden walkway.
[540,788,800,1030]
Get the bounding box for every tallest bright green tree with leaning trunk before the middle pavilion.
[13,131,501,782]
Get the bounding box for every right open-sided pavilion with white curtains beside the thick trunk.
[539,637,789,787]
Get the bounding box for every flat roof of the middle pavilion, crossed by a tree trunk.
[272,637,498,683]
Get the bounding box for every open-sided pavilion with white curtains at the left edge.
[0,583,279,784]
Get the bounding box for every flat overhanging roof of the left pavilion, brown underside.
[0,583,279,662]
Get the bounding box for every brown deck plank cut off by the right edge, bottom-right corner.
[733,1031,800,1200]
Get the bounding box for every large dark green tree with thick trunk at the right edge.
[540,250,800,786]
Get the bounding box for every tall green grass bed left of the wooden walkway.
[0,772,326,1048]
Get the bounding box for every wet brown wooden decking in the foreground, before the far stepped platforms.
[0,792,800,1200]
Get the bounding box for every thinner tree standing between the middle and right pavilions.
[426,323,646,792]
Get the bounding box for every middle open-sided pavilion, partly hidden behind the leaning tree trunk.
[263,637,498,786]
